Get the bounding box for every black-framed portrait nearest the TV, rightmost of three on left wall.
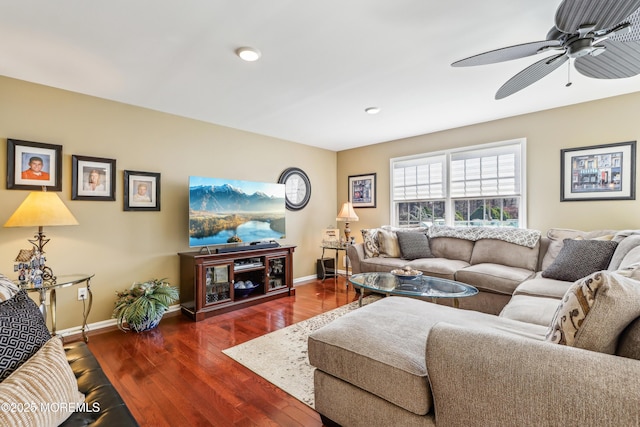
[124,170,160,211]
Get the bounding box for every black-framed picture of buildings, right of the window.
[560,141,636,202]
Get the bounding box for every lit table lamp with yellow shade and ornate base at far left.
[4,188,78,283]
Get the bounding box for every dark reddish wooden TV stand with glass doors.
[178,246,296,322]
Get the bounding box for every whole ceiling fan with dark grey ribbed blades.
[451,0,640,99]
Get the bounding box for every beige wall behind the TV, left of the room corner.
[0,78,337,329]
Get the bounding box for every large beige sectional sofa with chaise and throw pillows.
[308,227,640,426]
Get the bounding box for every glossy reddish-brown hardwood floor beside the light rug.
[83,278,357,427]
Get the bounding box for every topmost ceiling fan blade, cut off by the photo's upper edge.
[556,0,640,34]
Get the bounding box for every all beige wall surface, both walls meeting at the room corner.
[0,78,640,329]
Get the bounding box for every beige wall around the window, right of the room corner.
[337,93,640,236]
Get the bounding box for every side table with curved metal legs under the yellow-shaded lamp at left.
[17,274,94,342]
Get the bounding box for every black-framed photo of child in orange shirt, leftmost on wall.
[7,139,62,191]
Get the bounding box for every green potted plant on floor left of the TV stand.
[111,279,179,332]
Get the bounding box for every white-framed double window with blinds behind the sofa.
[391,139,526,228]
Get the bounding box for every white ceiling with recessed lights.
[0,0,640,151]
